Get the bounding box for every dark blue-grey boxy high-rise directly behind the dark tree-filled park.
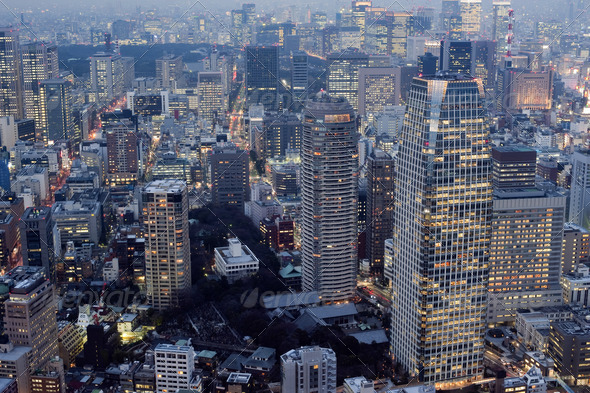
[210,144,250,209]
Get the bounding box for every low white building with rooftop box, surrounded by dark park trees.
[214,239,259,283]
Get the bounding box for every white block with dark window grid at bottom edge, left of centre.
[154,344,195,393]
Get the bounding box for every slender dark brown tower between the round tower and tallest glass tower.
[367,149,395,280]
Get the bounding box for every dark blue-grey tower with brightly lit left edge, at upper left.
[37,79,74,146]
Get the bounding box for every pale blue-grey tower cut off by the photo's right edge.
[567,150,590,229]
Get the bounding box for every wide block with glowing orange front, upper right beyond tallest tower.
[496,68,553,112]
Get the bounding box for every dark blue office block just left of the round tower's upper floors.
[262,113,303,158]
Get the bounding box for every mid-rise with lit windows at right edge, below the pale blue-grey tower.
[561,222,590,274]
